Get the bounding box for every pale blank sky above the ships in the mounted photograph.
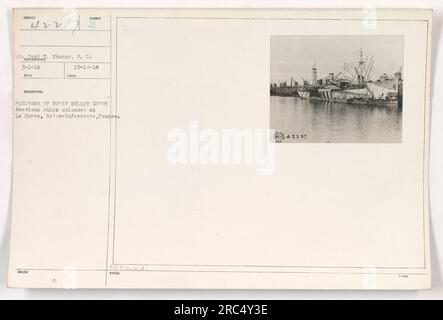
[271,35,403,83]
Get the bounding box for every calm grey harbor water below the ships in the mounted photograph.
[270,96,402,143]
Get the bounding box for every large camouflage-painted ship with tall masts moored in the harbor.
[297,48,403,107]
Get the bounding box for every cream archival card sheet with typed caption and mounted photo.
[9,9,431,289]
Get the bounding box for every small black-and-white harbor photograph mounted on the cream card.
[269,35,404,143]
